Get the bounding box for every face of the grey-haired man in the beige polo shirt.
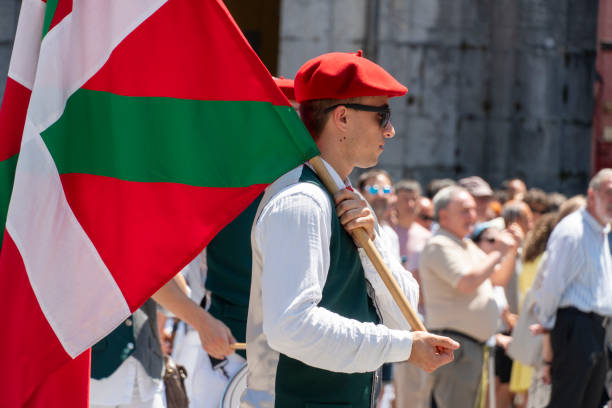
[440,191,476,238]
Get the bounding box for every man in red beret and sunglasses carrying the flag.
[242,52,459,408]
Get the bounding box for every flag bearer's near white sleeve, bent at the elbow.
[254,183,412,373]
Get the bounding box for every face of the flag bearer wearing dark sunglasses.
[346,96,395,168]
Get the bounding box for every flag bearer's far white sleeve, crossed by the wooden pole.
[359,228,419,330]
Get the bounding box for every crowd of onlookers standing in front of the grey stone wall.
[359,169,612,408]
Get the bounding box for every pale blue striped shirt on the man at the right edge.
[535,208,612,329]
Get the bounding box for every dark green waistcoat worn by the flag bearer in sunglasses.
[275,166,379,408]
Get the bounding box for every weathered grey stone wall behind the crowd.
[279,0,597,194]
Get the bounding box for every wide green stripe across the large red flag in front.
[42,89,318,187]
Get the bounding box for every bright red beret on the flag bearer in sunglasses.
[295,51,408,103]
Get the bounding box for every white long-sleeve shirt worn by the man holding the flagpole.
[244,161,418,406]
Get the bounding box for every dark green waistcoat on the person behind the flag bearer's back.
[206,193,263,358]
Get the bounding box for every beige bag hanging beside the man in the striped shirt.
[507,289,542,367]
